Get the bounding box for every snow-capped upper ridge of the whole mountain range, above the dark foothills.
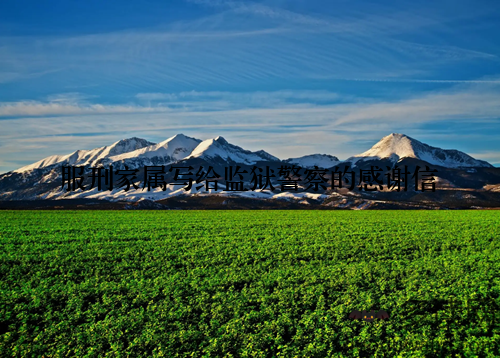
[12,133,493,173]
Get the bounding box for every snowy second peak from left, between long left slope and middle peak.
[109,134,201,162]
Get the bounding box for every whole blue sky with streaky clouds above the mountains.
[0,0,500,173]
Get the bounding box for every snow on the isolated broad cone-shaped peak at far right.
[346,133,493,168]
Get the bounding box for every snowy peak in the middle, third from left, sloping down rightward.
[186,136,279,165]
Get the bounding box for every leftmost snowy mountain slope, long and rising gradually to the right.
[14,137,154,173]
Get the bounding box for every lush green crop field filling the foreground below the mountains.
[0,211,500,358]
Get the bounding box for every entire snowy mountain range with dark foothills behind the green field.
[0,133,500,209]
